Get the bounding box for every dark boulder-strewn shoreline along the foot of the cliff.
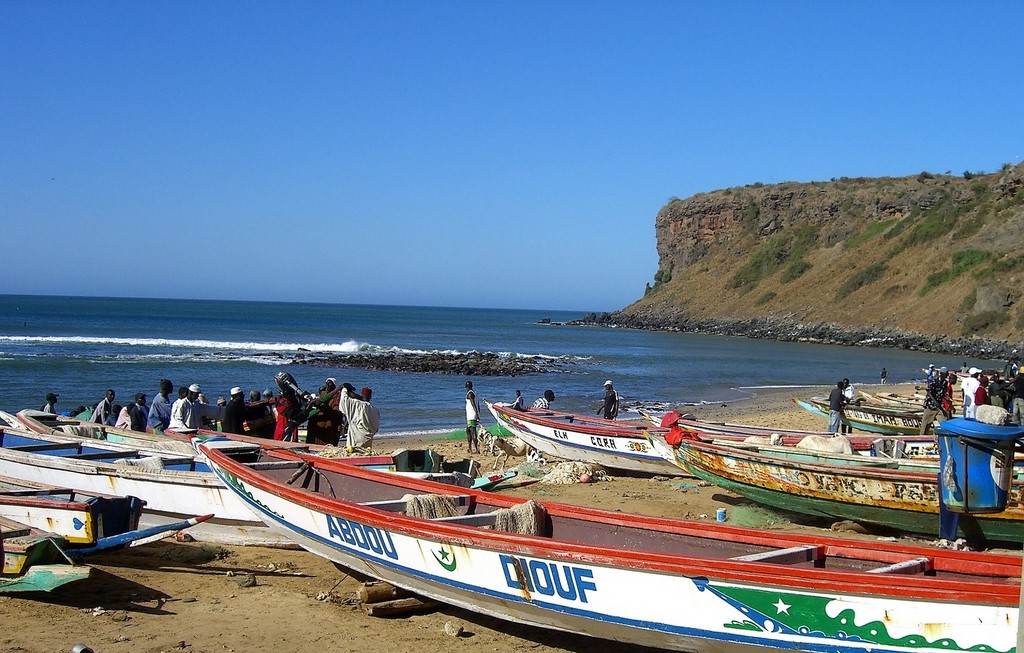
[566,310,1024,360]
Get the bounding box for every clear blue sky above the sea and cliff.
[0,0,1024,311]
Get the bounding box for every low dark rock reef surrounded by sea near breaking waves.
[292,352,568,377]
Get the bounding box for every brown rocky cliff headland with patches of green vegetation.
[590,164,1024,355]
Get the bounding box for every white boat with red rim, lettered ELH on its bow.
[483,401,683,476]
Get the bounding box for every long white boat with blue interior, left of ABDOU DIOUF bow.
[0,430,291,547]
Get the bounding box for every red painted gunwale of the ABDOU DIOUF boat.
[201,445,1021,606]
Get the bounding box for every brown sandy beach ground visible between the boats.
[0,386,991,653]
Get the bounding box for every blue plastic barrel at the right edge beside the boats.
[936,418,1024,513]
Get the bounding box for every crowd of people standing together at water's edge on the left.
[41,373,380,450]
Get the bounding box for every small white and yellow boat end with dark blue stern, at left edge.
[0,477,145,547]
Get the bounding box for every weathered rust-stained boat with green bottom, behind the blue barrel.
[650,432,1024,546]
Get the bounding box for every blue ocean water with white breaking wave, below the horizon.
[0,295,1001,436]
